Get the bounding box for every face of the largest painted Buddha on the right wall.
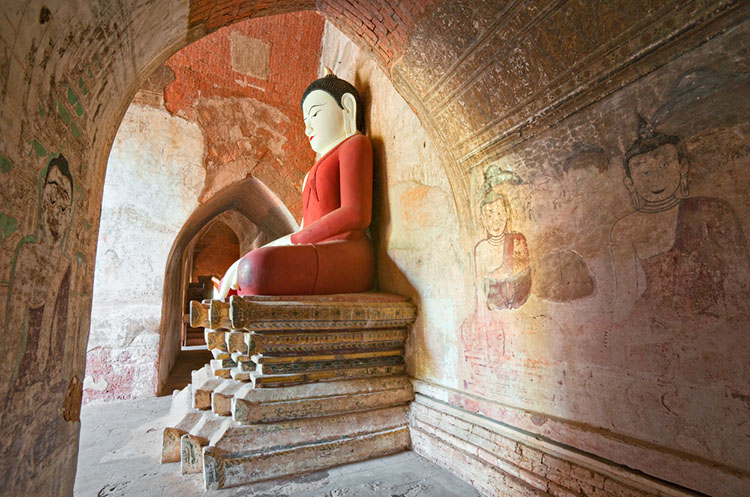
[629,144,681,202]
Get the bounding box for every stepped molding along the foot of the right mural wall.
[410,380,746,497]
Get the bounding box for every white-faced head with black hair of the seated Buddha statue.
[301,74,365,154]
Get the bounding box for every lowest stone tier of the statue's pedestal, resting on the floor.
[202,407,410,490]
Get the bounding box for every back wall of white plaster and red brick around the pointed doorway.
[84,12,323,401]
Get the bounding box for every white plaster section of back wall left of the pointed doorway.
[83,97,206,402]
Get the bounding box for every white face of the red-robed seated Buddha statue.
[302,90,346,154]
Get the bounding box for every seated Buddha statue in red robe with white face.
[214,74,375,299]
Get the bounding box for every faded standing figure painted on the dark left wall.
[0,154,88,480]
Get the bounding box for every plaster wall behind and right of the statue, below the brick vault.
[322,8,750,495]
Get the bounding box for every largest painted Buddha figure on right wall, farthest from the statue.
[610,117,750,323]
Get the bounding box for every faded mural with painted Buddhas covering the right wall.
[460,19,750,471]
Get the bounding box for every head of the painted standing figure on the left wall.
[41,154,73,242]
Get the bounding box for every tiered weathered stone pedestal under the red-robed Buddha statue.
[162,294,416,489]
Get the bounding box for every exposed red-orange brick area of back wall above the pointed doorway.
[164,12,324,218]
